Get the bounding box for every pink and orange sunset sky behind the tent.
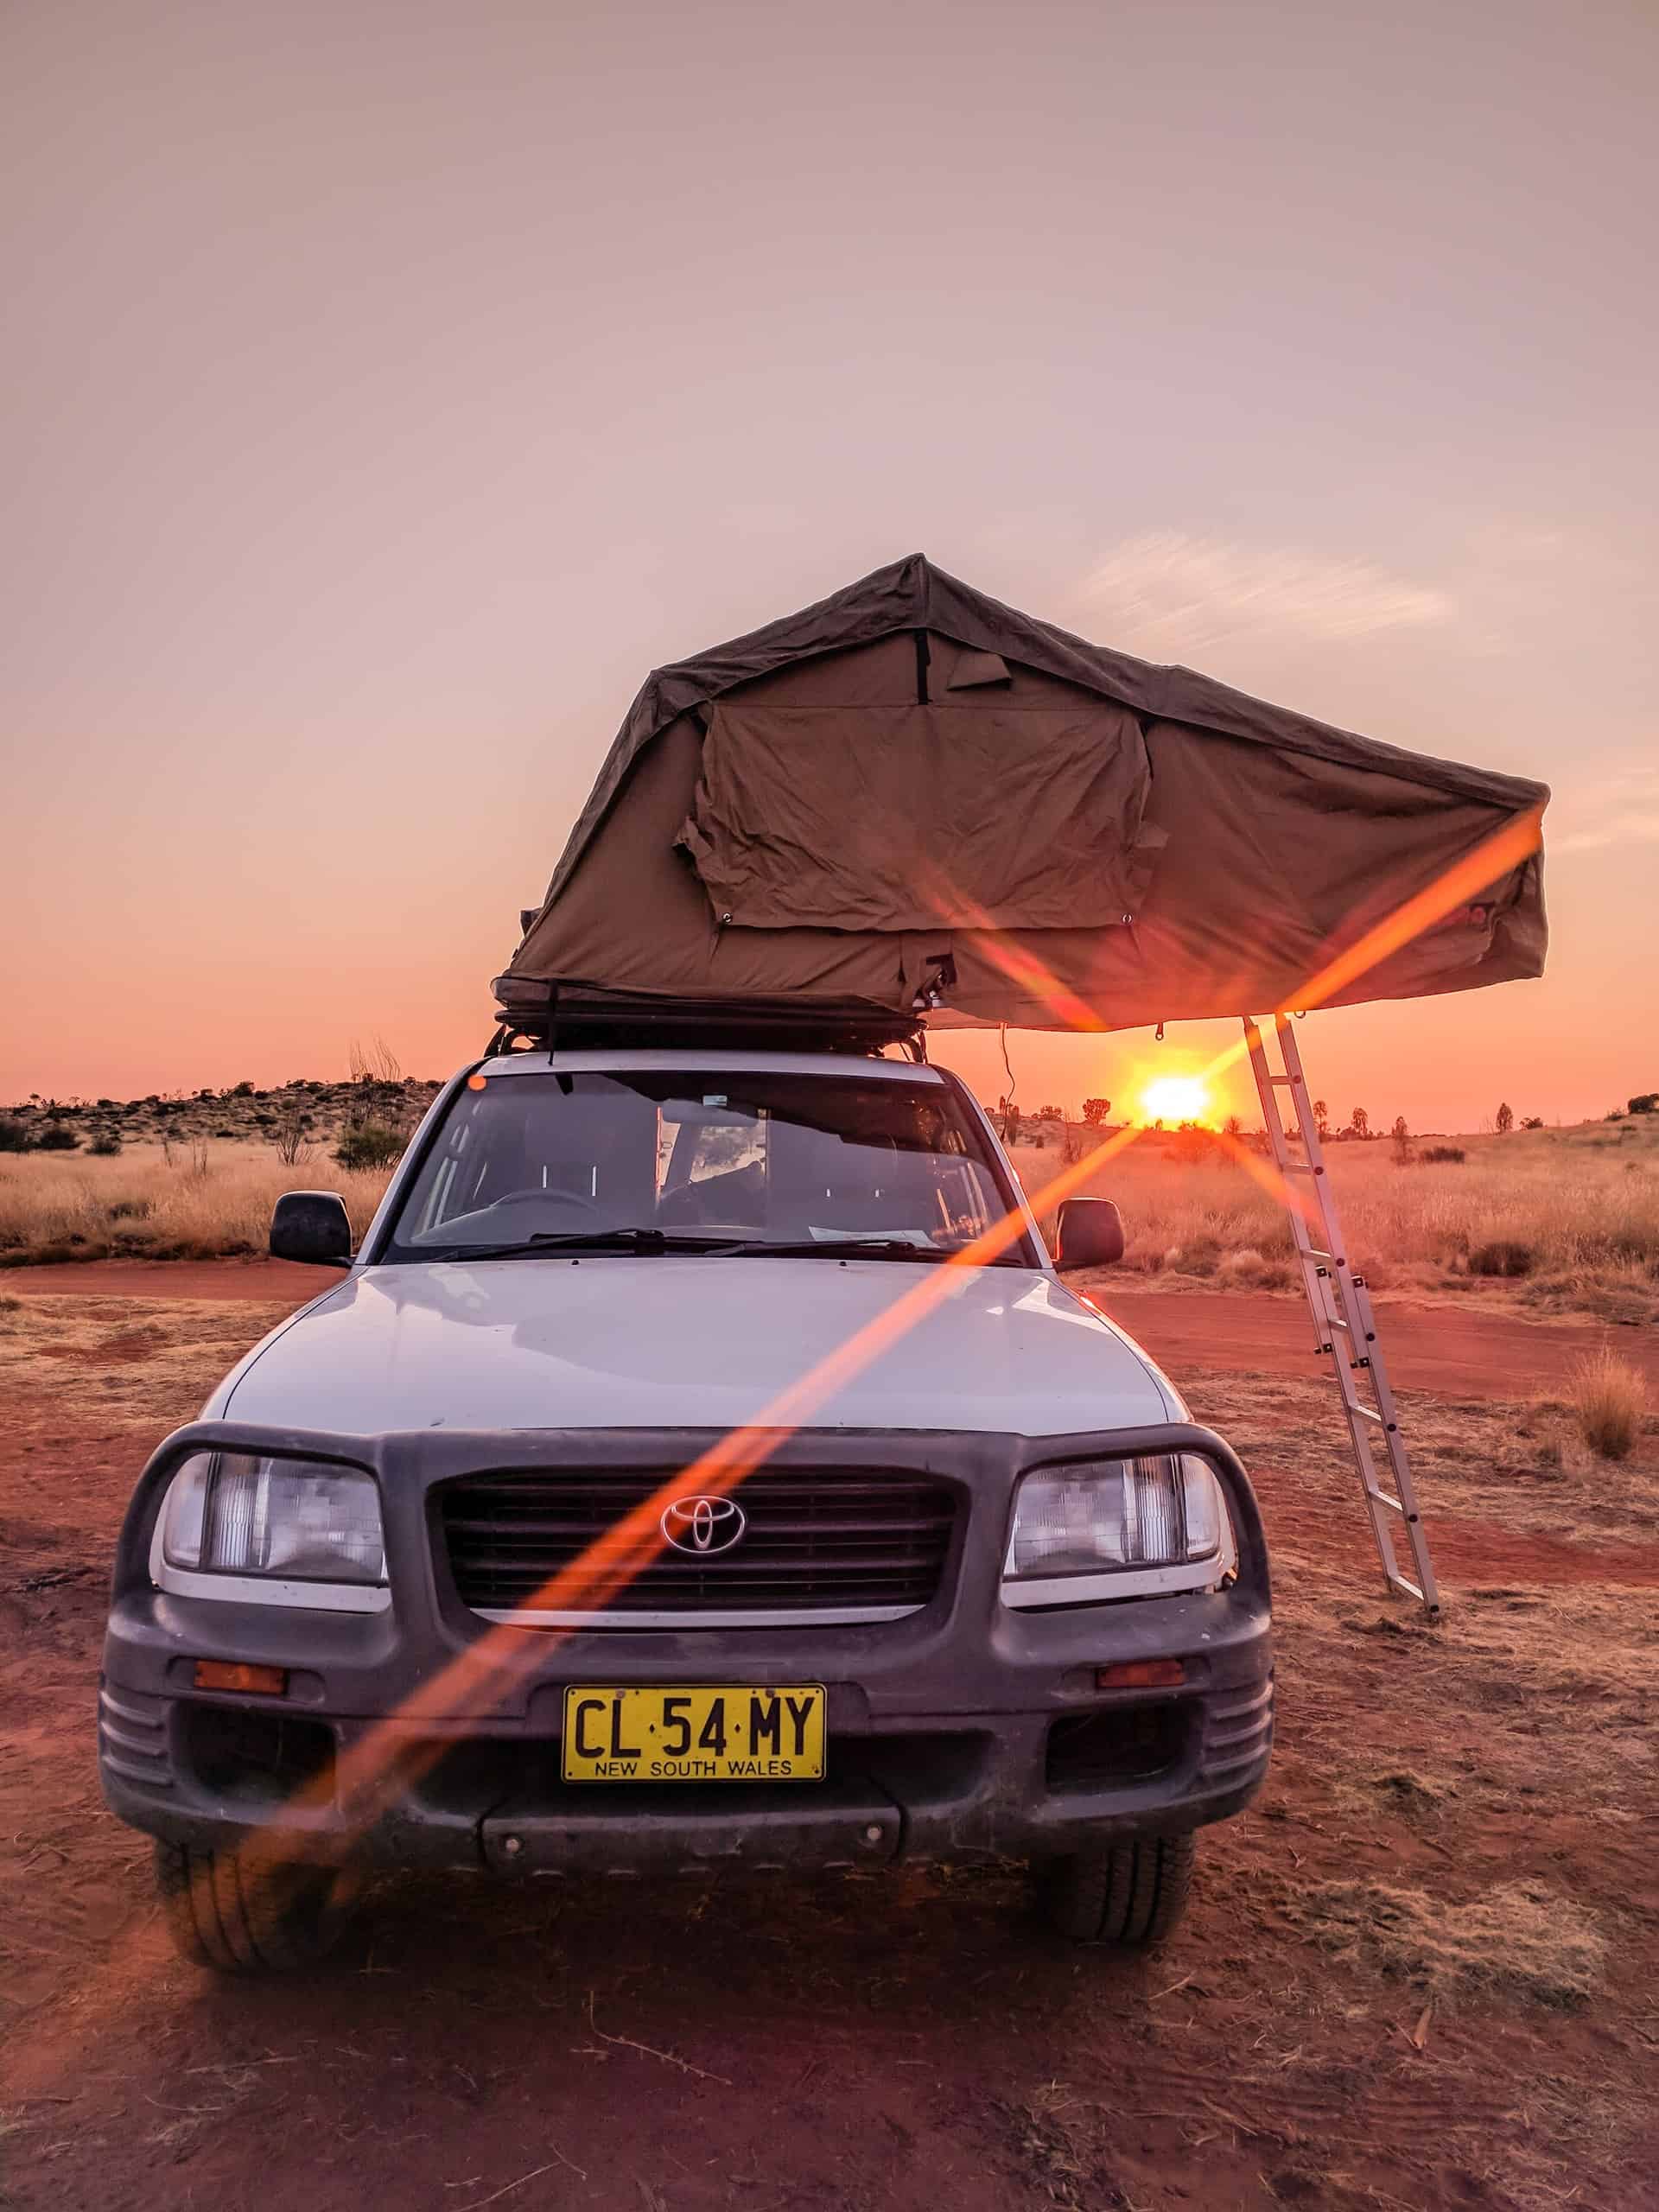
[0,0,1659,1128]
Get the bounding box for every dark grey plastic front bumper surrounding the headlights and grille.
[99,1422,1272,1873]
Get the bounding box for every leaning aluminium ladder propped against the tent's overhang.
[1243,1013,1440,1617]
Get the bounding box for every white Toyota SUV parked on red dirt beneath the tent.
[99,1048,1272,1971]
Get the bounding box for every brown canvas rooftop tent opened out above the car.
[495,556,1548,1028]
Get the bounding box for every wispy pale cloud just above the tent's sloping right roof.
[1079,531,1453,659]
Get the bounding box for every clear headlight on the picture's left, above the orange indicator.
[159,1451,385,1601]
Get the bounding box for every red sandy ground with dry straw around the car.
[0,1269,1659,2212]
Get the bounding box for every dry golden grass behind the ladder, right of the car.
[1013,1117,1659,1323]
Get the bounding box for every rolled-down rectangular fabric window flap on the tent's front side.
[679,692,1164,931]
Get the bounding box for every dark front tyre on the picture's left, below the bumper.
[155,1842,356,1974]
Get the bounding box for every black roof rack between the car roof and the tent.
[486,982,927,1059]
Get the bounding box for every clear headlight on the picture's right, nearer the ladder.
[1002,1451,1236,1606]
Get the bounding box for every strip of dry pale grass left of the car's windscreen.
[0,1141,391,1265]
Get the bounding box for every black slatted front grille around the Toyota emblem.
[440,1466,956,1619]
